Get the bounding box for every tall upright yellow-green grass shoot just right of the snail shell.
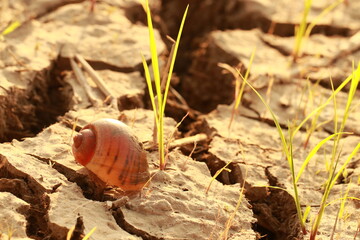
[142,0,189,170]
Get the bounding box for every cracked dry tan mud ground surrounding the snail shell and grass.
[0,0,360,240]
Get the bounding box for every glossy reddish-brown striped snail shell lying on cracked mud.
[72,119,150,191]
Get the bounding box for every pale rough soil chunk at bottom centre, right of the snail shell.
[121,151,256,239]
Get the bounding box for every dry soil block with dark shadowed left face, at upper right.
[181,29,360,112]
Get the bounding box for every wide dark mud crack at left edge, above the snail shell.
[0,58,72,142]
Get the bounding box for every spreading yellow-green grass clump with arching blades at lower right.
[237,64,360,236]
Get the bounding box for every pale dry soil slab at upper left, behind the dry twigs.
[41,2,165,71]
